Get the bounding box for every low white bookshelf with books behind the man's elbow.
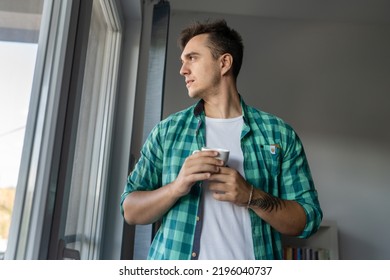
[282,221,339,260]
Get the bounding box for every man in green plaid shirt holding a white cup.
[121,20,322,259]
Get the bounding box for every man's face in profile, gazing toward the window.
[180,34,221,98]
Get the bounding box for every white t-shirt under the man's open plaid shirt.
[199,116,254,260]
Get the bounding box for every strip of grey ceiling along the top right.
[168,0,390,23]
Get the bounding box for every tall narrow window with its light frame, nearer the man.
[63,1,121,259]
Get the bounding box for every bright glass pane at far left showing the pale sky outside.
[0,0,43,259]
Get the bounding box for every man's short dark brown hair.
[178,20,244,78]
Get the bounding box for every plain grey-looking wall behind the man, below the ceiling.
[164,11,390,259]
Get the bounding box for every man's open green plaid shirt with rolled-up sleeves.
[121,97,322,260]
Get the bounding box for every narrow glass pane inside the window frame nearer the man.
[65,1,110,259]
